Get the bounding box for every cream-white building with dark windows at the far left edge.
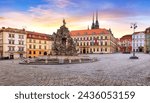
[0,27,27,59]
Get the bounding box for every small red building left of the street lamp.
[120,35,132,53]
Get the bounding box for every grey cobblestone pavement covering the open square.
[0,54,150,86]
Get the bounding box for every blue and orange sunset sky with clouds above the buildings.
[0,0,150,37]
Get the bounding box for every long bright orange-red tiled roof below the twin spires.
[70,29,110,36]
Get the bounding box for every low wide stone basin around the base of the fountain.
[20,56,98,65]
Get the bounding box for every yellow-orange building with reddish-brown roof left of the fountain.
[27,31,52,58]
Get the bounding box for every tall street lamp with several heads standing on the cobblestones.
[130,23,138,59]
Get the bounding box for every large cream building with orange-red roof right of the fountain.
[70,29,117,54]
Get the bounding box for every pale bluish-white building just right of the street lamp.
[132,31,145,52]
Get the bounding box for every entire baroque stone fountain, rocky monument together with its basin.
[20,20,97,65]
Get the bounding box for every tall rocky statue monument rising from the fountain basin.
[52,19,77,56]
